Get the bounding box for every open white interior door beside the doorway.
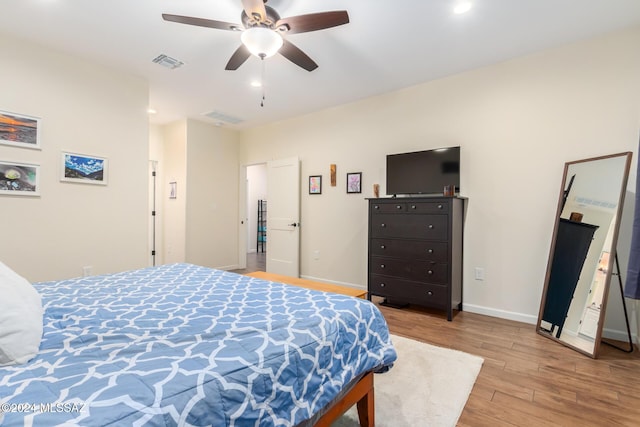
[267,157,300,277]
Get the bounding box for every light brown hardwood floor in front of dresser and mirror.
[374,299,640,427]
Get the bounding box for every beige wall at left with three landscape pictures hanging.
[0,35,149,281]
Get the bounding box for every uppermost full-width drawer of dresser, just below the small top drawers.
[371,214,448,240]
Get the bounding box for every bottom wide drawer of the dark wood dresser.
[369,274,448,308]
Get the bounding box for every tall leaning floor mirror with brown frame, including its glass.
[537,152,631,358]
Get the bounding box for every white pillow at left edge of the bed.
[0,262,44,366]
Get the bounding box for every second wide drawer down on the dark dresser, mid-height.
[369,239,449,262]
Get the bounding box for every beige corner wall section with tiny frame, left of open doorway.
[156,119,239,269]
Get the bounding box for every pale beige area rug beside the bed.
[332,335,484,427]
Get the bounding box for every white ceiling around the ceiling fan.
[0,0,640,128]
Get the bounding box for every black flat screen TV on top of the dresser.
[387,147,460,195]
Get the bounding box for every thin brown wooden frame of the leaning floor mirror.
[536,151,632,359]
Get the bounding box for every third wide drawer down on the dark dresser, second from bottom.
[369,257,449,284]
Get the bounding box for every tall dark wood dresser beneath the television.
[368,197,465,321]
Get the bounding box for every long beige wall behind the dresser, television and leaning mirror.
[241,28,640,330]
